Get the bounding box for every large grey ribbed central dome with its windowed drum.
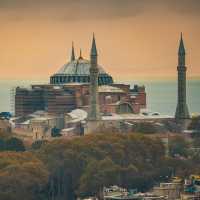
[50,56,113,85]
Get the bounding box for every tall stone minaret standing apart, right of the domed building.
[175,33,190,120]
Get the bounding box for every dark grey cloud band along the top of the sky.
[0,0,200,20]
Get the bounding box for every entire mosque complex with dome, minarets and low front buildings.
[14,34,190,139]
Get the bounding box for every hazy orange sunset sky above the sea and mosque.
[0,0,200,80]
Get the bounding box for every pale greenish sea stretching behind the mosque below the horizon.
[0,80,200,115]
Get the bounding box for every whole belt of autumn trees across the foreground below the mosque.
[0,134,200,200]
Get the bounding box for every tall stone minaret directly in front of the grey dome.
[88,34,100,121]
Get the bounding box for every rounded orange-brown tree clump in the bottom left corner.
[0,152,48,200]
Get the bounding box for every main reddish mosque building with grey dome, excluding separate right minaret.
[15,37,146,117]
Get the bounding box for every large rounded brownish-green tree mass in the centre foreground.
[39,134,164,199]
